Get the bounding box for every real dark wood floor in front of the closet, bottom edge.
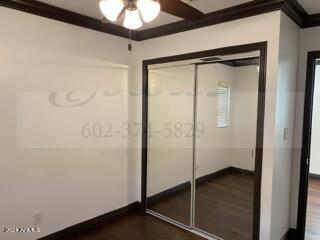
[68,213,204,240]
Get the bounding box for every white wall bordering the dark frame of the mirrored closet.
[129,11,280,240]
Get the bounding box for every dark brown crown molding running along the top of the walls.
[0,0,320,41]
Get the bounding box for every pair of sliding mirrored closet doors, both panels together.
[143,44,264,240]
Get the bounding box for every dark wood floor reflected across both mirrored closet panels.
[148,172,254,240]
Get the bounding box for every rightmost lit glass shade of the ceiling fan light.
[137,0,161,22]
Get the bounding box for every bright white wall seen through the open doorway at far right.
[310,65,320,175]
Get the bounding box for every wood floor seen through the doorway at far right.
[305,178,320,240]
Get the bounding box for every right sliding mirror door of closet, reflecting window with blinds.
[194,53,259,240]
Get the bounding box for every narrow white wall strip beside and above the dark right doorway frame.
[291,27,320,227]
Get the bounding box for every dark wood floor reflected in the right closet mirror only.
[195,172,254,240]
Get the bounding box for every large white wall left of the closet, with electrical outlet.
[0,7,137,240]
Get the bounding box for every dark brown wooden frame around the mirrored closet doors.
[141,42,268,240]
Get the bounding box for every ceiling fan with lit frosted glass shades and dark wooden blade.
[100,0,204,30]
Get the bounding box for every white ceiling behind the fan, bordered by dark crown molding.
[40,0,320,30]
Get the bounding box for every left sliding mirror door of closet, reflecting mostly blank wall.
[147,65,195,227]
